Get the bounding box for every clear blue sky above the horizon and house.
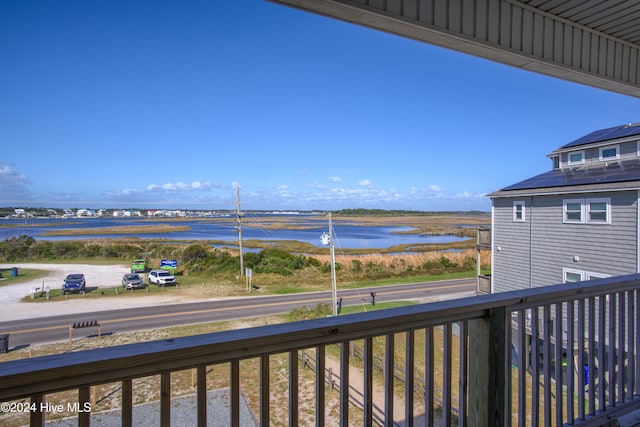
[0,0,640,211]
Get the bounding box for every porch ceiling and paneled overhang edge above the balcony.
[271,0,640,97]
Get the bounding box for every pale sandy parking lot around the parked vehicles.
[0,264,188,321]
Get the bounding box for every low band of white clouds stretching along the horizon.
[0,161,487,210]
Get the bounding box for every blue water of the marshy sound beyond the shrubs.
[0,215,466,249]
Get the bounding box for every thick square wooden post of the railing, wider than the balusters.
[468,307,507,427]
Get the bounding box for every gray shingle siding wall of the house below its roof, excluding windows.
[492,191,638,292]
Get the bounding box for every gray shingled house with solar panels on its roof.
[488,123,640,292]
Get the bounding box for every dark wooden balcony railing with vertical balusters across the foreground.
[0,275,640,426]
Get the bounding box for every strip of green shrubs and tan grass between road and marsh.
[0,235,488,293]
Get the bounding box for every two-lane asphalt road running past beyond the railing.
[0,279,476,349]
